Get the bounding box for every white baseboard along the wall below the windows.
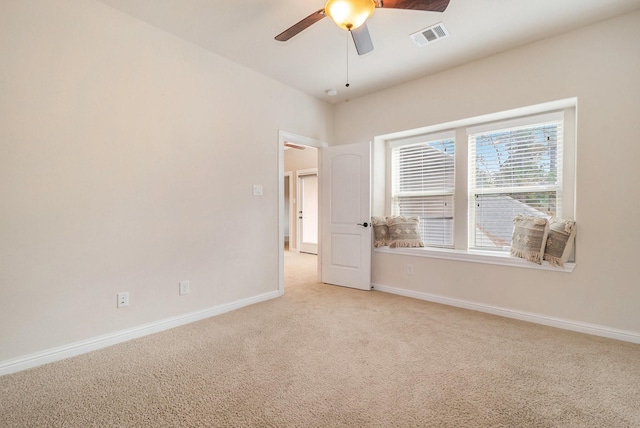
[372,284,640,344]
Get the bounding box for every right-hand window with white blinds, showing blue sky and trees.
[467,113,563,251]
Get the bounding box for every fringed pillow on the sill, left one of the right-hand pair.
[511,215,549,264]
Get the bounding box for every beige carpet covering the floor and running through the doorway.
[0,254,640,427]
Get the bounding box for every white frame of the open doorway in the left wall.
[278,130,329,295]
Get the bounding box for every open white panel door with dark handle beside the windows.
[321,143,371,290]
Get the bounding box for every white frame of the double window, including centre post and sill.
[372,98,577,272]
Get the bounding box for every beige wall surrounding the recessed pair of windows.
[335,12,640,332]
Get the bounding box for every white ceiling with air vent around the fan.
[100,0,640,103]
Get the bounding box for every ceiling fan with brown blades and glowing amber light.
[275,0,449,55]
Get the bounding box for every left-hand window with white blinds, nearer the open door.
[391,133,455,248]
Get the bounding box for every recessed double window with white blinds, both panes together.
[374,99,576,261]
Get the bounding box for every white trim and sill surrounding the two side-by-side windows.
[372,98,577,272]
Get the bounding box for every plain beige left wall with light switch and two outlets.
[0,0,332,363]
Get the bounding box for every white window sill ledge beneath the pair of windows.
[373,247,576,272]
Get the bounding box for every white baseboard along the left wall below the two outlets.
[0,290,282,376]
